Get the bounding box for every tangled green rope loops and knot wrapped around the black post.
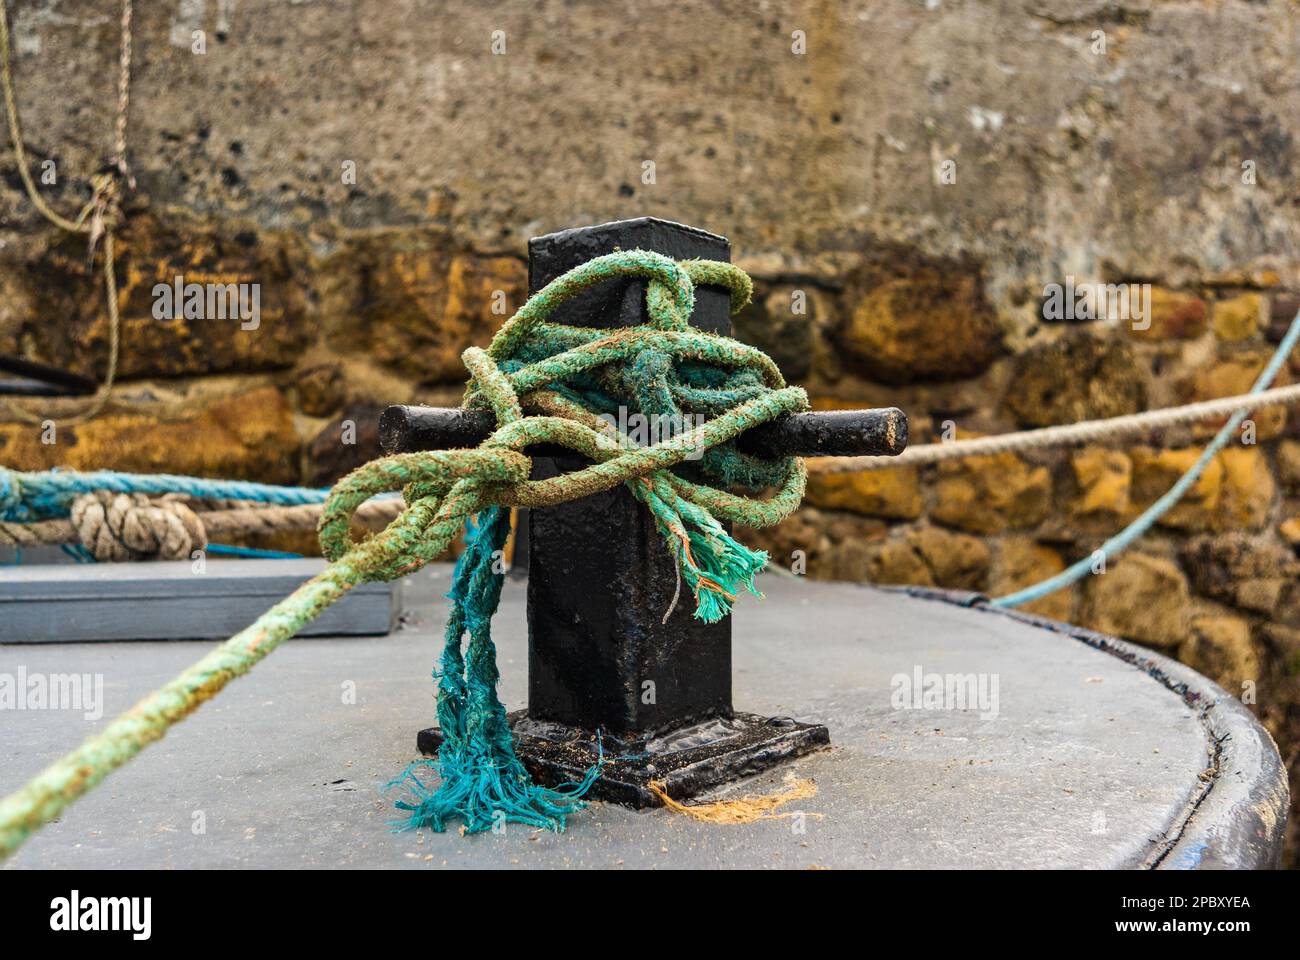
[309,250,807,600]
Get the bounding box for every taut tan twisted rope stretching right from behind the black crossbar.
[809,384,1300,473]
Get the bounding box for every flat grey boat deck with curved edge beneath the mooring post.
[0,566,1286,869]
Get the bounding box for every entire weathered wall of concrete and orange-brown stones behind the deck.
[0,0,1300,858]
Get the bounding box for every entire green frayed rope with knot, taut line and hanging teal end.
[0,250,807,856]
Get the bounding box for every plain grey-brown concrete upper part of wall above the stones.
[5,0,1300,270]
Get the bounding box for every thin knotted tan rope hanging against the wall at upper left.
[0,0,135,424]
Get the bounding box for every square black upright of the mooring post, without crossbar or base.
[528,219,732,738]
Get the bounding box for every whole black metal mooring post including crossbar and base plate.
[408,217,907,807]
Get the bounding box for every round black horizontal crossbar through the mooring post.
[380,406,907,458]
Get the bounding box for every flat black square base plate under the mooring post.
[416,710,831,809]
